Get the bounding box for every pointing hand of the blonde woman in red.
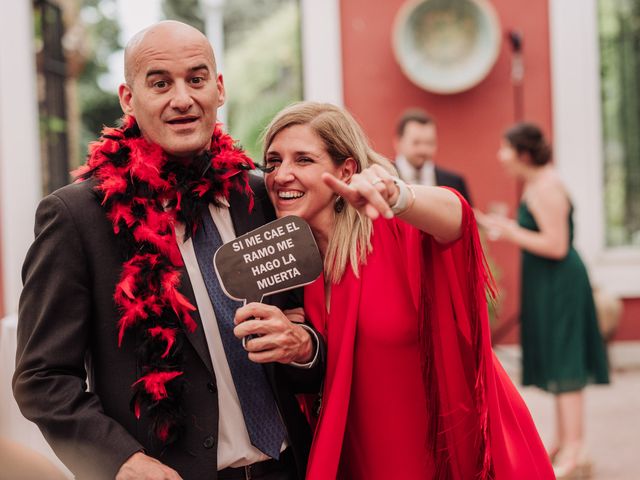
[322,165,399,220]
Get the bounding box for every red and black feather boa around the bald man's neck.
[74,116,255,444]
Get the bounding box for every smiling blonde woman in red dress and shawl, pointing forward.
[236,102,553,480]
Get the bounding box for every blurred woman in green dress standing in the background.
[478,123,609,479]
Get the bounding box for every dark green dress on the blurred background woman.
[518,202,609,393]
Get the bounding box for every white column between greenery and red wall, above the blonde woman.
[300,0,344,106]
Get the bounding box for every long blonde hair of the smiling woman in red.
[263,102,396,283]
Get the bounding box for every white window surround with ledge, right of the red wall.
[549,0,640,298]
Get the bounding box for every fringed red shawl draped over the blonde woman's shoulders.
[305,192,554,480]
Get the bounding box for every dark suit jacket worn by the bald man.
[13,175,323,480]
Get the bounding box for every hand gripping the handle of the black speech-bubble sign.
[233,302,314,363]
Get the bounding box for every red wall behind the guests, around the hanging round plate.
[341,0,640,341]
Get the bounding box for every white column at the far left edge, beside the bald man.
[0,1,42,315]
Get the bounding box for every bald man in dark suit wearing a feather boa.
[13,22,323,480]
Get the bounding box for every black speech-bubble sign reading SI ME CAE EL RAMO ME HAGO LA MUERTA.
[213,216,322,303]
